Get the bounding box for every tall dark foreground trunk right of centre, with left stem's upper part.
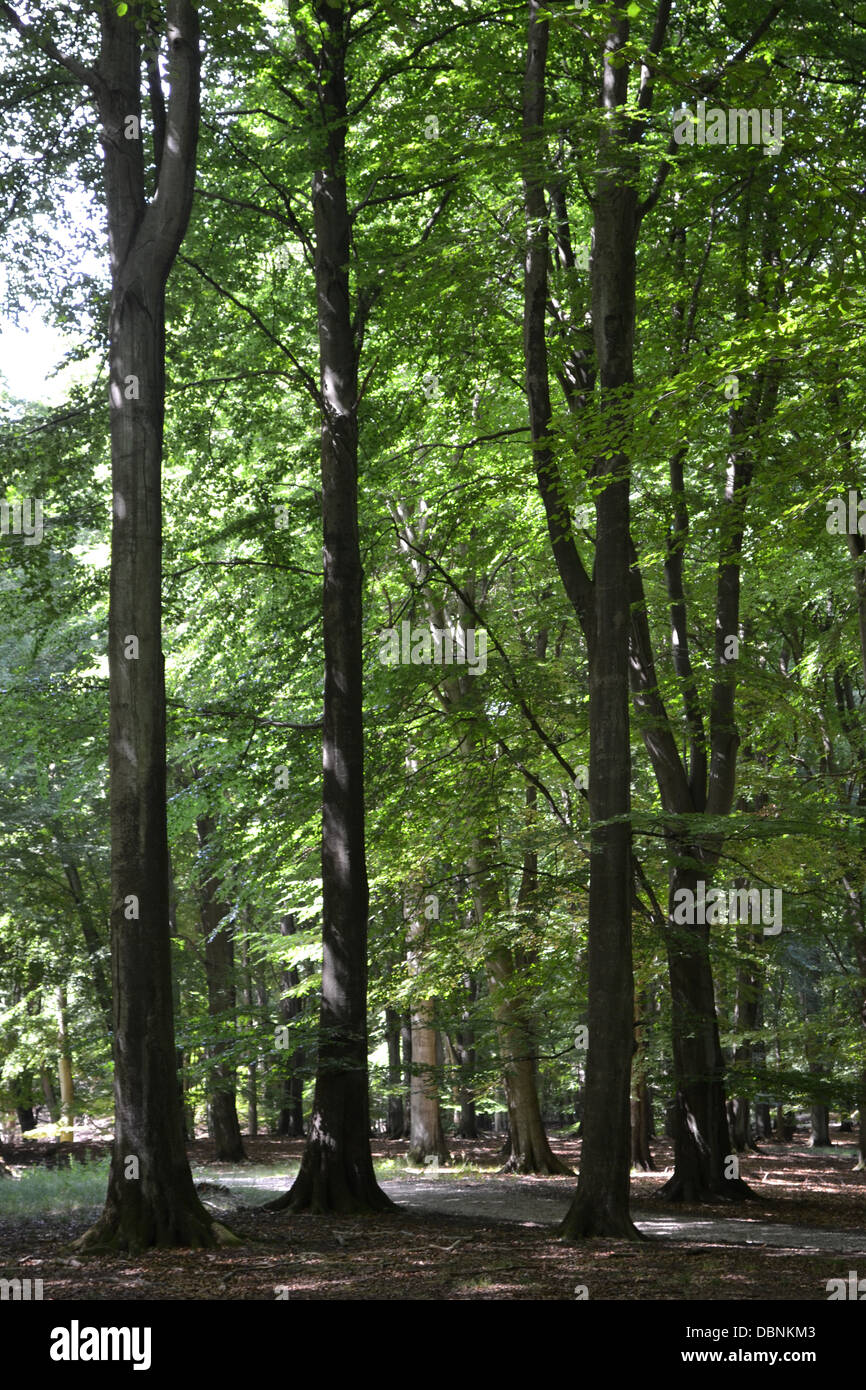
[547,0,639,1240]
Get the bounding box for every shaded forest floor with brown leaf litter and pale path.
[0,1136,866,1301]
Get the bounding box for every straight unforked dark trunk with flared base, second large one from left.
[270,0,393,1212]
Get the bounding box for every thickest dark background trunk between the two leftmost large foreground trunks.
[196,816,246,1163]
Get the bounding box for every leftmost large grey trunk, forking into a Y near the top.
[69,0,222,1251]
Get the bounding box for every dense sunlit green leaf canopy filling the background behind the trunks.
[0,0,866,1156]
